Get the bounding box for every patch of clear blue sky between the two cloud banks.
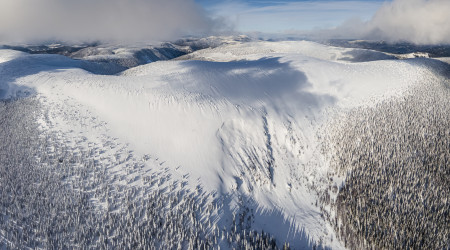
[196,0,384,32]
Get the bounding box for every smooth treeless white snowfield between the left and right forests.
[0,41,446,249]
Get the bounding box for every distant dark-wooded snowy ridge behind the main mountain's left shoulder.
[0,35,251,75]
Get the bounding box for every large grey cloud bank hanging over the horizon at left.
[0,0,219,42]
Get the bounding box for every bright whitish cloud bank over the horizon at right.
[322,0,450,44]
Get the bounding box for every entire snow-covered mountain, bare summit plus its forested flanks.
[0,41,450,249]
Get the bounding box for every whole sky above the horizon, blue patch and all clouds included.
[0,0,450,44]
